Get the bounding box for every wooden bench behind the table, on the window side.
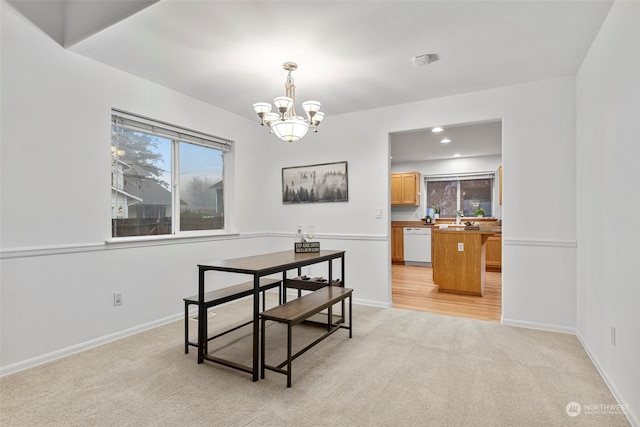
[184,278,282,353]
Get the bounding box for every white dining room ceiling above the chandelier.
[10,0,612,160]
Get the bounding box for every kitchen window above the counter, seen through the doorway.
[425,173,494,218]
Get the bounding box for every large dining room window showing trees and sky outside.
[111,110,231,237]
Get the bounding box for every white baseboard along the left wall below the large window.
[0,313,184,377]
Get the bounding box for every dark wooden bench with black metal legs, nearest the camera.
[260,286,353,387]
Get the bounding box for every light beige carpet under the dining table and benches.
[0,296,629,427]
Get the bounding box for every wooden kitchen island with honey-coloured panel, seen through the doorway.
[431,227,495,296]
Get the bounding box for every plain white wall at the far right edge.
[577,1,640,425]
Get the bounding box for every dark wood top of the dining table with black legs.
[198,249,344,275]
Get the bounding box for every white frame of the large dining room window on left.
[107,108,235,244]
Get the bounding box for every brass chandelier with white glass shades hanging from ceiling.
[253,62,324,142]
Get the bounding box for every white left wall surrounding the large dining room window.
[0,2,268,372]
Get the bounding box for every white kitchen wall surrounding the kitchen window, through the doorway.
[391,155,502,221]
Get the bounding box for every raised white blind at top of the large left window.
[111,109,231,151]
